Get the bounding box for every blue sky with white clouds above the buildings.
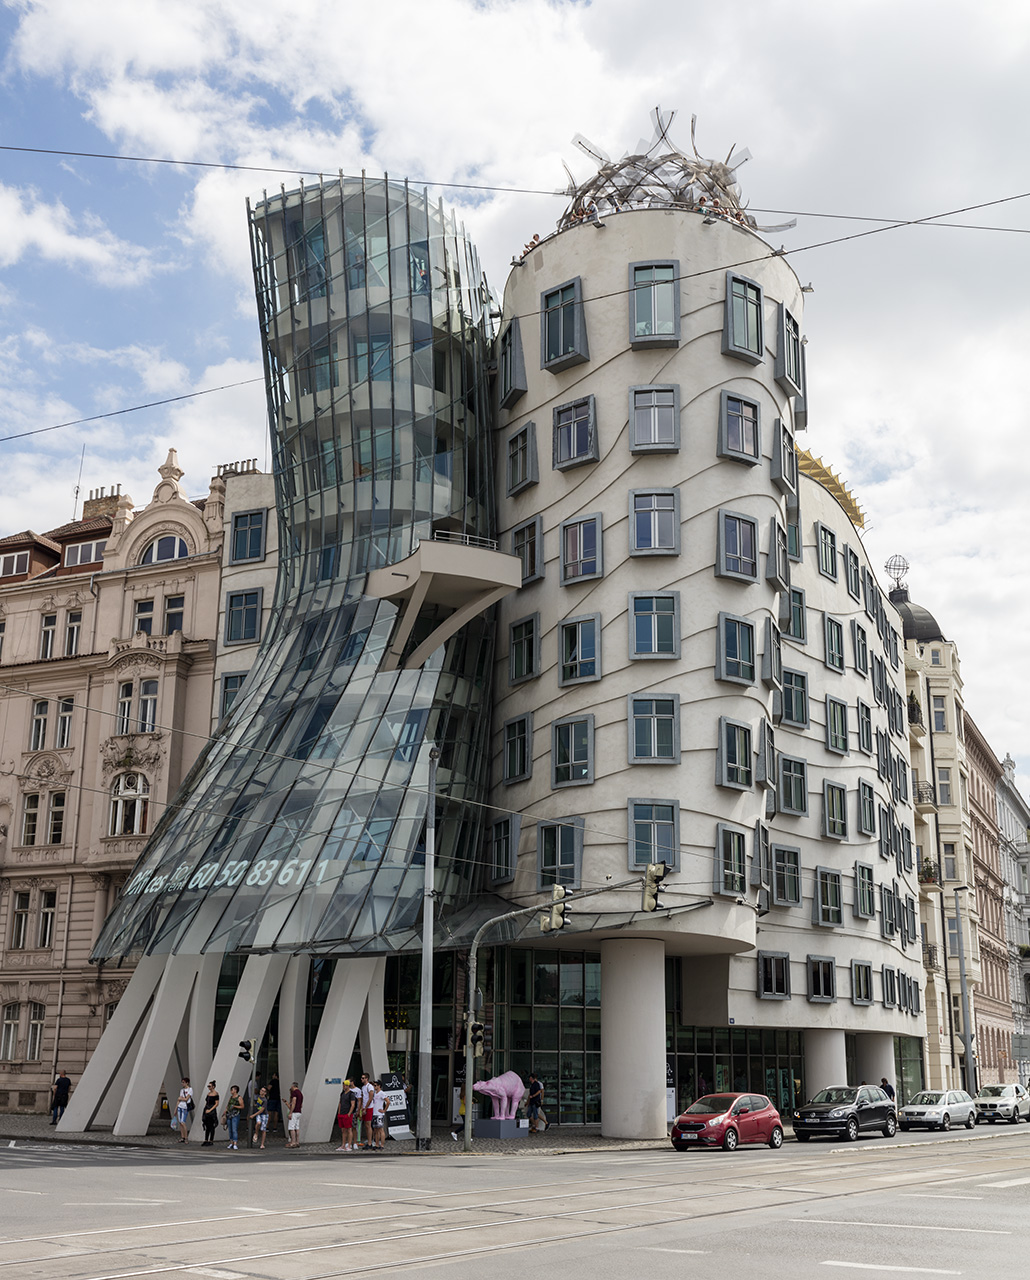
[0,0,1030,794]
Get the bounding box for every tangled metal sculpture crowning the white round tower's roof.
[558,106,796,230]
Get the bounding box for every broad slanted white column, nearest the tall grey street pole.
[301,956,385,1142]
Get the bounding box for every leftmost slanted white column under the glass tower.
[58,956,166,1133]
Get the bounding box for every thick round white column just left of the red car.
[601,938,665,1138]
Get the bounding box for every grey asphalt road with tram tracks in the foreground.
[0,1125,1030,1280]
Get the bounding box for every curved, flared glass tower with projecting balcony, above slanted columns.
[93,177,504,960]
